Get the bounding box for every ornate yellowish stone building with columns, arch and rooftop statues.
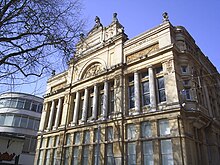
[35,13,220,165]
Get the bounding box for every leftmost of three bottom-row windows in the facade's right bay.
[127,142,136,165]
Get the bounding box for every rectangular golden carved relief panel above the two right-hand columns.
[127,43,159,63]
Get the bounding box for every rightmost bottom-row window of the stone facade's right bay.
[160,139,174,165]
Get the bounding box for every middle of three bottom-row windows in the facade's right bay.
[143,141,154,165]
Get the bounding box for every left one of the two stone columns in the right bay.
[134,72,141,114]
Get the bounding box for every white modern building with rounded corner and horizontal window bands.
[0,92,43,165]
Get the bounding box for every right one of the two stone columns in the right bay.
[148,67,156,111]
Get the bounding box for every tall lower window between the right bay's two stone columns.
[141,81,150,105]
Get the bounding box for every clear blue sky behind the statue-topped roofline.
[3,0,220,96]
